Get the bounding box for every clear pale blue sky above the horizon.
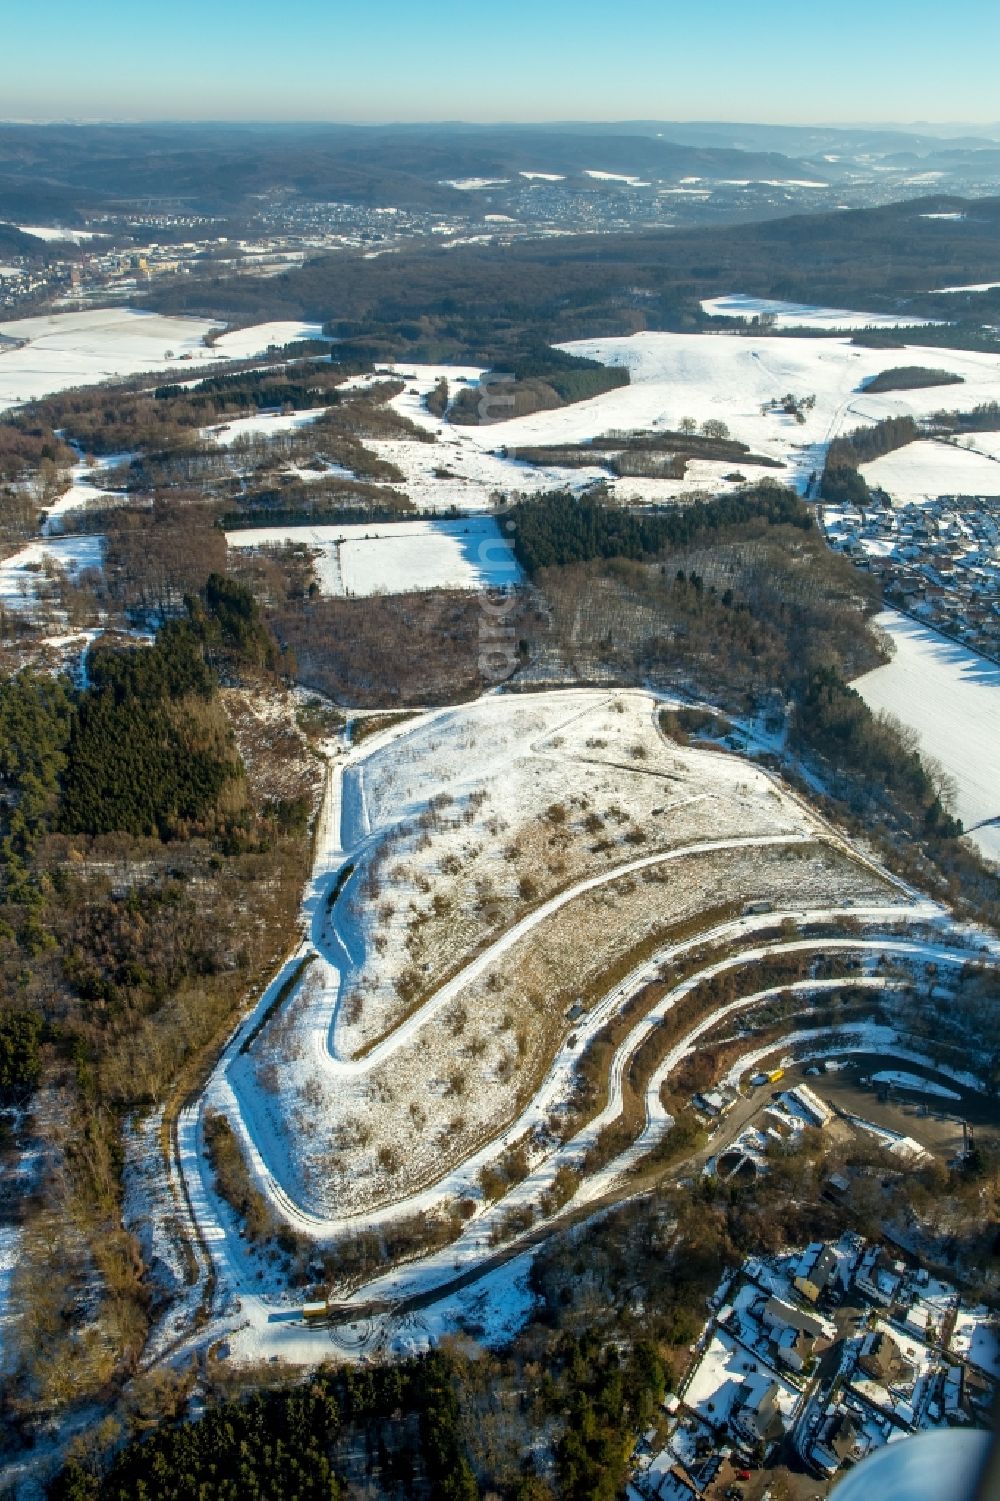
[7,0,1000,123]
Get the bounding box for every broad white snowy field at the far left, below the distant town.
[0,308,321,411]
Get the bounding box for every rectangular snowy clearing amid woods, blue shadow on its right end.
[225,516,521,597]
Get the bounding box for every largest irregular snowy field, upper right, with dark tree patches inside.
[346,333,1000,509]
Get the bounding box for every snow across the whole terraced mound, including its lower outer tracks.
[156,660,982,1363]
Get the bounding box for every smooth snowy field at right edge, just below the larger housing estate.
[854,609,1000,862]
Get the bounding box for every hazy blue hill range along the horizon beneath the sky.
[0,122,1000,224]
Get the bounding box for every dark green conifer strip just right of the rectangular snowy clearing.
[511,485,812,576]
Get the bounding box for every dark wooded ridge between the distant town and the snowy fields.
[138,195,1000,358]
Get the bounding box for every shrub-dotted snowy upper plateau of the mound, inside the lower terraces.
[210,690,896,1235]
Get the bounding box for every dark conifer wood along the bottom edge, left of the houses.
[48,1351,479,1501]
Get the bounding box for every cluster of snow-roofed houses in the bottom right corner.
[631,1234,1000,1501]
